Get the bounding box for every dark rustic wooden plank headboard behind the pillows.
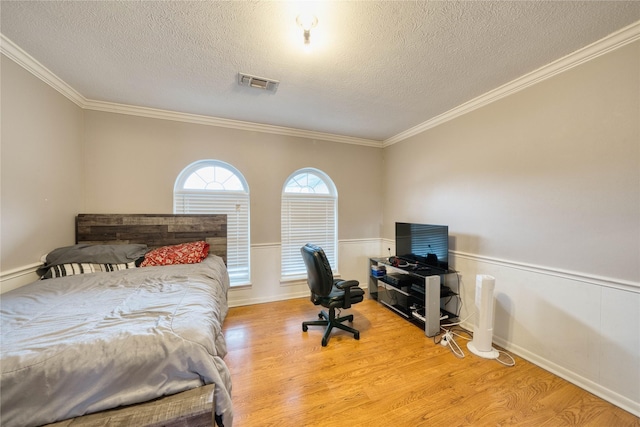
[76,214,227,263]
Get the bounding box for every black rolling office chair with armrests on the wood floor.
[300,243,364,347]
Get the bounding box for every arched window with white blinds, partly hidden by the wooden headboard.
[173,160,251,286]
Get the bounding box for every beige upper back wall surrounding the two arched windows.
[85,111,382,244]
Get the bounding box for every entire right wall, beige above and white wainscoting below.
[383,42,640,415]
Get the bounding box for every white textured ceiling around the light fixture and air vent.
[0,0,640,141]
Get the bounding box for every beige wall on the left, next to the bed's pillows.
[0,55,84,271]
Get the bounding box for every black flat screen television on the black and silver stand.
[396,222,449,270]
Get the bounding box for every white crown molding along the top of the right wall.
[382,21,640,147]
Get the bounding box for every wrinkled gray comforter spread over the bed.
[0,255,233,427]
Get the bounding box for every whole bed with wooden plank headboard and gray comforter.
[0,214,233,427]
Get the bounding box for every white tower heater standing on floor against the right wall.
[467,274,499,359]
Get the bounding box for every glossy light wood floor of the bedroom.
[224,298,640,427]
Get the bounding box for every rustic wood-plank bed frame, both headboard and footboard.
[47,214,227,427]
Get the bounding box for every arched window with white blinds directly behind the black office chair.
[280,168,338,280]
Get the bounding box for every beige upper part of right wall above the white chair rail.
[383,42,640,282]
